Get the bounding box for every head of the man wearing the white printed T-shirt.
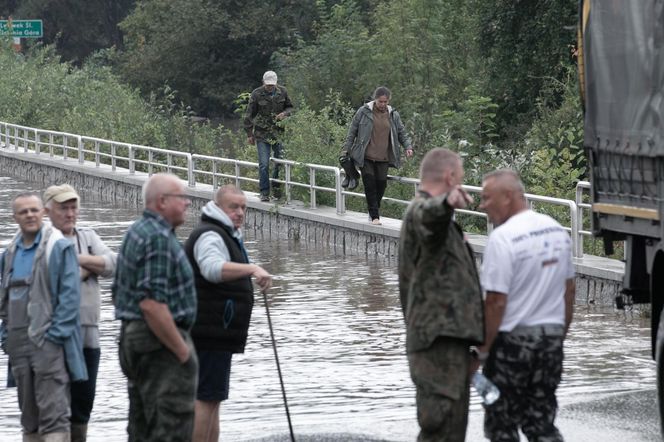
[480,169,528,225]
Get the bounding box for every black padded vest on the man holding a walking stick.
[184,214,254,353]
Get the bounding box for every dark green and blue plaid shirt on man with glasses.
[112,209,196,328]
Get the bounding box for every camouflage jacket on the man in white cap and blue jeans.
[244,85,293,142]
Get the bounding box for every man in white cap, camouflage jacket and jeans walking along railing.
[244,71,293,201]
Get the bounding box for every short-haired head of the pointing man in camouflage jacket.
[420,147,463,196]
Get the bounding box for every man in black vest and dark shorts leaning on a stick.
[185,185,272,442]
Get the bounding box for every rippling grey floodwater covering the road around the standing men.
[0,174,659,442]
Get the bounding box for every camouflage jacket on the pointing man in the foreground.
[399,191,484,353]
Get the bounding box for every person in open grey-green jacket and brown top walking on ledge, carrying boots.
[343,86,413,225]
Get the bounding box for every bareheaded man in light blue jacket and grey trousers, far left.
[0,193,87,442]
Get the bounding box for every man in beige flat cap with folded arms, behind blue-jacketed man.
[44,184,116,442]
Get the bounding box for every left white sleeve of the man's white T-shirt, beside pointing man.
[481,234,513,295]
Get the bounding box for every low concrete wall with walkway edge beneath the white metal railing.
[0,146,624,305]
